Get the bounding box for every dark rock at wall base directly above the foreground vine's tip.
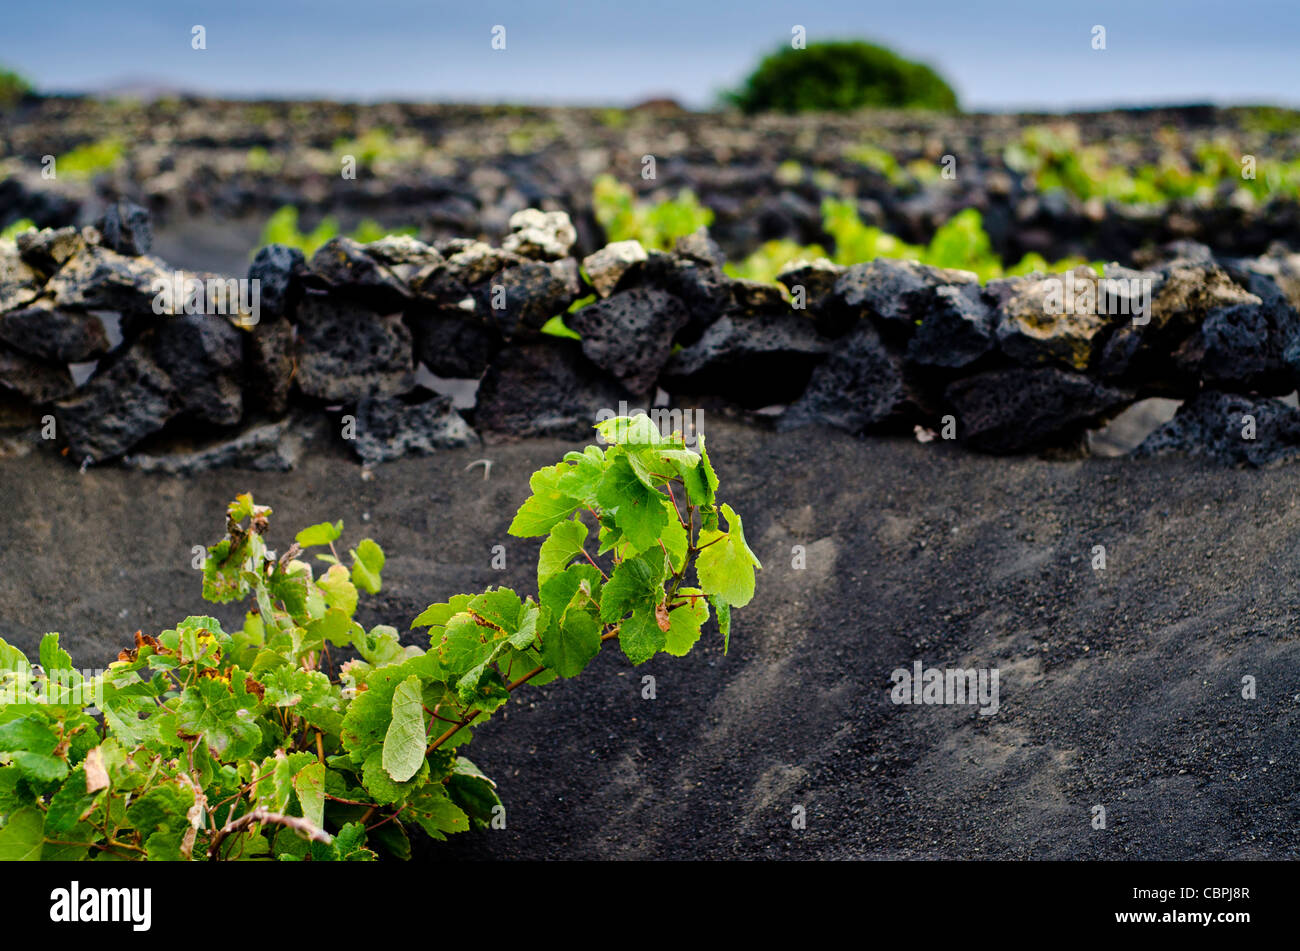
[473,339,632,442]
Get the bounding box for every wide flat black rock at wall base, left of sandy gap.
[945,366,1132,452]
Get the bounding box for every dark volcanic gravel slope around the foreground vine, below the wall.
[0,418,1300,859]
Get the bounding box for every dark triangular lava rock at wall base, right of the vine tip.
[777,321,906,434]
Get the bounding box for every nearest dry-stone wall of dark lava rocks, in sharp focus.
[0,201,1300,472]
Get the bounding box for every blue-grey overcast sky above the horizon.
[0,0,1300,109]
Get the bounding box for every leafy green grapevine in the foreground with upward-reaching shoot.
[0,414,759,861]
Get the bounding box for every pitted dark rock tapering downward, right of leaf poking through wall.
[567,287,689,395]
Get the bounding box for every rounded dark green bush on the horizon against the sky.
[727,42,957,113]
